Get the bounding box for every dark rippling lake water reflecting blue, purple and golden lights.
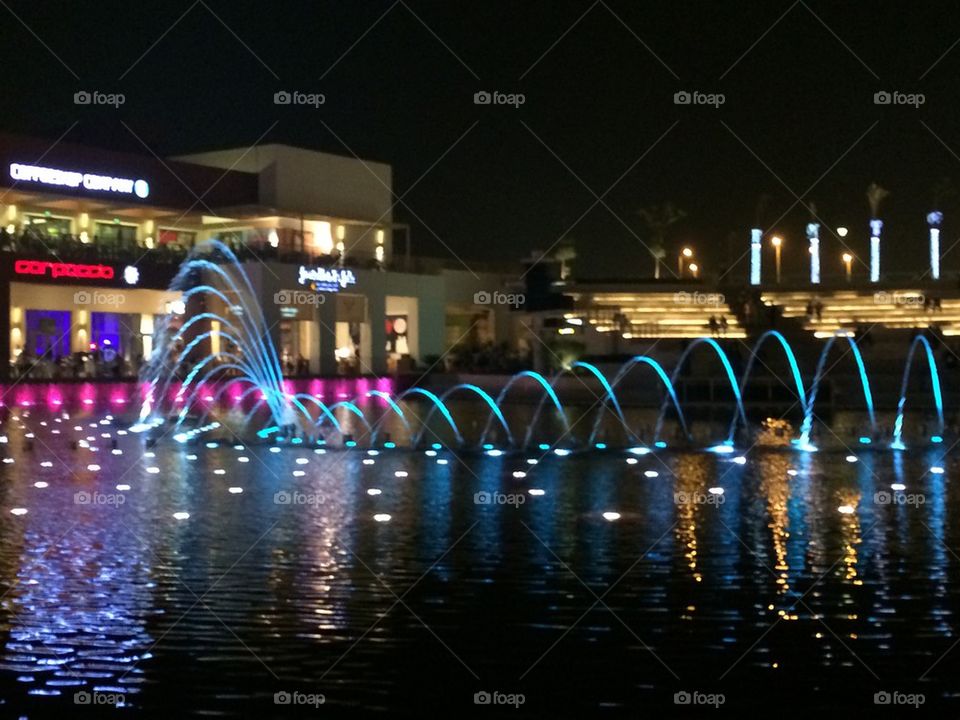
[0,404,960,718]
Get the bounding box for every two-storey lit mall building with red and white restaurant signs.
[0,135,515,378]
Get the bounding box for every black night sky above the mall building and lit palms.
[0,0,960,277]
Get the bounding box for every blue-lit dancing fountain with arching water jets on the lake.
[131,241,945,453]
